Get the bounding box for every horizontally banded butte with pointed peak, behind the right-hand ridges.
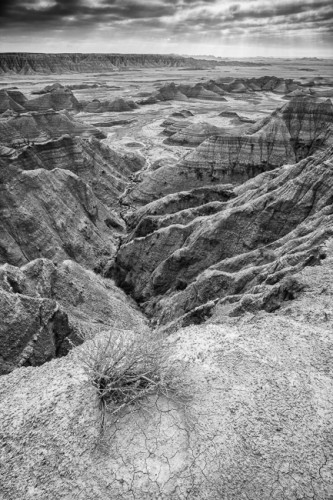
[128,98,333,203]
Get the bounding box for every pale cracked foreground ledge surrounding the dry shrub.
[0,266,333,500]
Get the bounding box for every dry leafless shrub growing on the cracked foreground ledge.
[80,328,189,424]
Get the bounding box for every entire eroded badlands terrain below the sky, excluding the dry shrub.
[0,54,333,500]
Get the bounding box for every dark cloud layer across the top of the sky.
[0,0,333,36]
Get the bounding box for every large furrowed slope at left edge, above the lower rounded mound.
[0,132,144,270]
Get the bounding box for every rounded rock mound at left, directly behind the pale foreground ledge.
[0,259,144,375]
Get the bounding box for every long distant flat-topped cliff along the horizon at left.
[0,52,216,75]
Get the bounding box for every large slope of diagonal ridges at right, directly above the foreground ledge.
[115,148,333,324]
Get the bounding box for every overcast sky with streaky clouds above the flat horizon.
[0,0,333,57]
